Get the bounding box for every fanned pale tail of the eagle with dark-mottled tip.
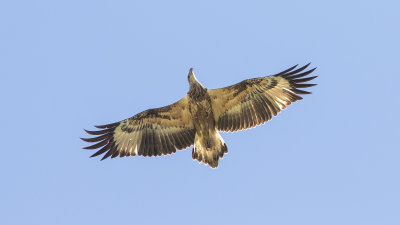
[192,131,228,168]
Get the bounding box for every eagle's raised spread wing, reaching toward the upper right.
[208,64,317,131]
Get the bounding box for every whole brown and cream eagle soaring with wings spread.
[81,63,317,168]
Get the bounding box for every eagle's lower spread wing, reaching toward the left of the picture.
[81,96,195,160]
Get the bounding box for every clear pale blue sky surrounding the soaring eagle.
[0,0,400,225]
